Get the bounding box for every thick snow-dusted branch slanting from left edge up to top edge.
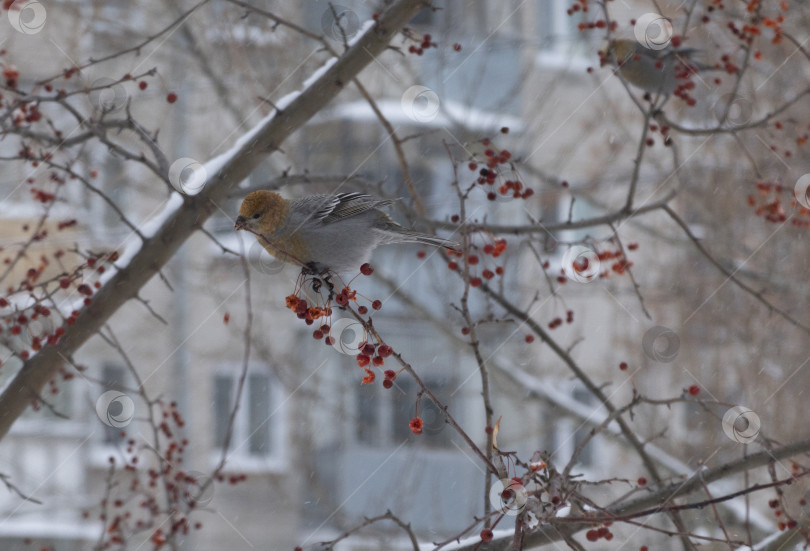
[0,0,429,444]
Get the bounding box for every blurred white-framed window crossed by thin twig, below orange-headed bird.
[213,371,284,468]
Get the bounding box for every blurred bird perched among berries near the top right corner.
[602,39,716,97]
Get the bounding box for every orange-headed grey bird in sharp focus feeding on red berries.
[234,190,459,274]
